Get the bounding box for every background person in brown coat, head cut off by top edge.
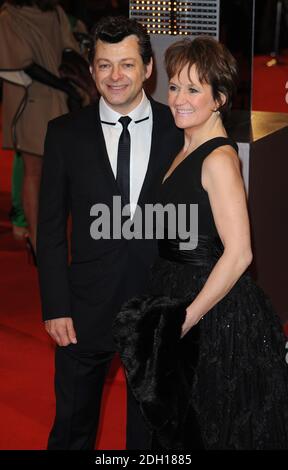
[0,0,78,250]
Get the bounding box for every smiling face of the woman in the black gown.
[168,64,219,129]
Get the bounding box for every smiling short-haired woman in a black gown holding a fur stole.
[115,37,288,450]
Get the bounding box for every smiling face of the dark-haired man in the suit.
[90,35,152,114]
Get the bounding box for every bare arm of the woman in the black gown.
[182,146,252,336]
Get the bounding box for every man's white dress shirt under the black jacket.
[99,90,153,217]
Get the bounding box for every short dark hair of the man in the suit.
[89,16,152,65]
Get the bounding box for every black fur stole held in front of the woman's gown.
[113,296,204,450]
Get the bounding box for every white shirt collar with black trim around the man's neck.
[99,90,151,126]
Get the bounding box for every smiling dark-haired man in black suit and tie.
[37,17,183,449]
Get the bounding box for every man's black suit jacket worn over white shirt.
[37,99,183,352]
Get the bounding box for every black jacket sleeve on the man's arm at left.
[37,122,71,320]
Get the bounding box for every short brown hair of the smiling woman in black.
[165,36,237,117]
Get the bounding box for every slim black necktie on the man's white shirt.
[116,116,131,204]
